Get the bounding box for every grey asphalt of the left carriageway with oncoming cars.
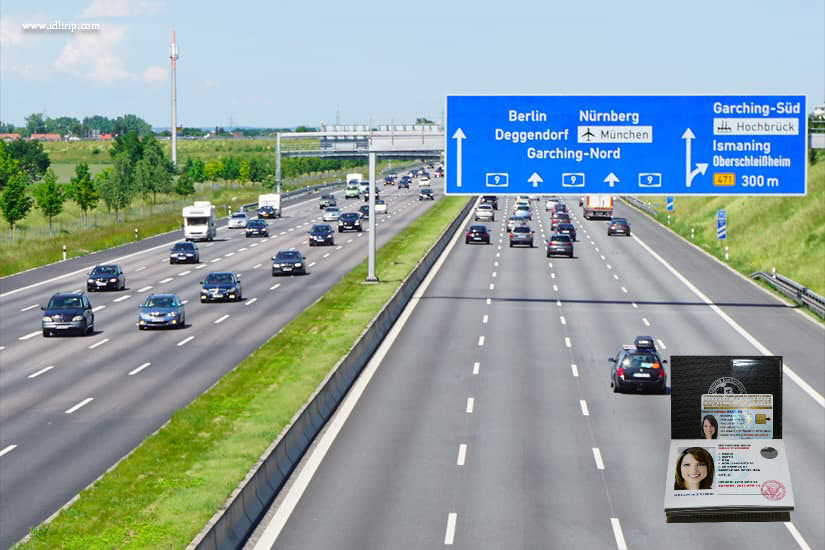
[0,180,442,548]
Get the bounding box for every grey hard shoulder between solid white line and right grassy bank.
[617,204,825,395]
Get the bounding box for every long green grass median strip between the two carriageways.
[23,197,467,550]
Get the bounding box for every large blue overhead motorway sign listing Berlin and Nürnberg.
[446,95,808,195]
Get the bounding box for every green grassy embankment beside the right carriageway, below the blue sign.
[628,160,825,295]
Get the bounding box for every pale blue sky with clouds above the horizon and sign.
[0,0,825,126]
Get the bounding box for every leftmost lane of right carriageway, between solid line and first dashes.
[275,209,493,548]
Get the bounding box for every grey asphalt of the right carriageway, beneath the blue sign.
[247,200,825,550]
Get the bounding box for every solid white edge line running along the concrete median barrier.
[254,196,472,550]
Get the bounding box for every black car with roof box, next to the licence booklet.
[608,336,667,393]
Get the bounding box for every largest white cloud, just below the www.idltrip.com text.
[54,25,137,84]
